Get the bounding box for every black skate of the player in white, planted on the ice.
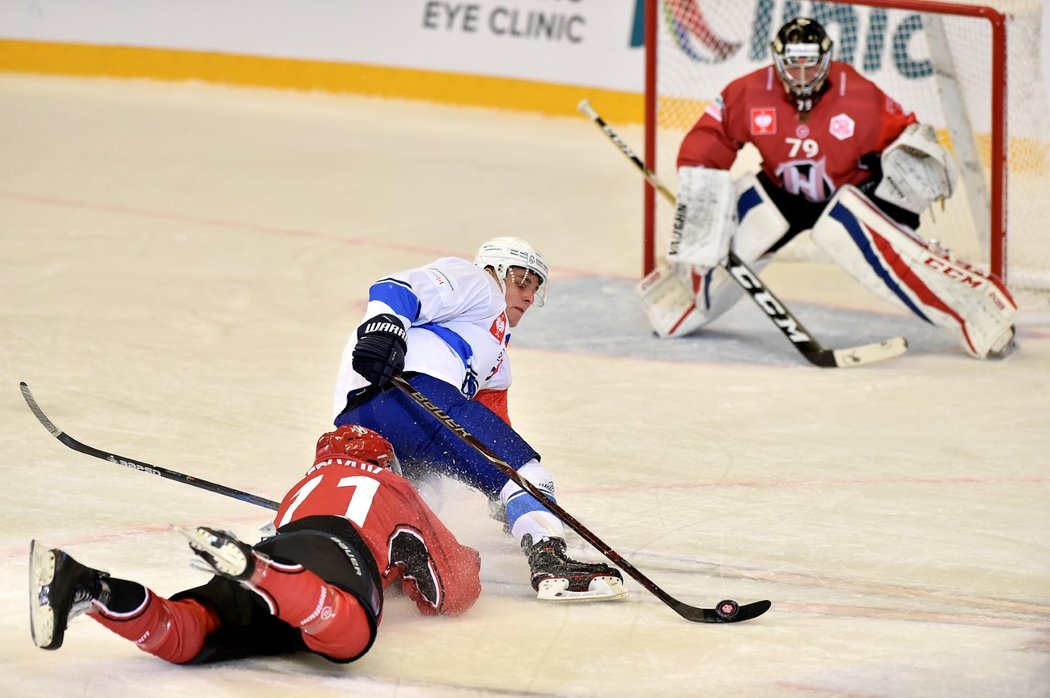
[522,534,627,601]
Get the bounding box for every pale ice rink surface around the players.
[0,75,1050,698]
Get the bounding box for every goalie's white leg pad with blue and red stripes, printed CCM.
[813,186,1017,359]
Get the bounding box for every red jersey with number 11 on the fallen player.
[274,459,481,615]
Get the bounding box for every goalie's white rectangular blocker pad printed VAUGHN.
[667,167,736,269]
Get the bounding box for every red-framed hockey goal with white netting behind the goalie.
[644,0,1050,312]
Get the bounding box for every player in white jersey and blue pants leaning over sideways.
[334,237,627,600]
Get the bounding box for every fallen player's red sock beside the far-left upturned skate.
[88,589,219,664]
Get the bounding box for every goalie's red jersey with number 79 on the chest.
[678,61,917,203]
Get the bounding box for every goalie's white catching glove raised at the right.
[875,124,959,215]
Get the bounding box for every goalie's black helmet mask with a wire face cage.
[772,17,833,111]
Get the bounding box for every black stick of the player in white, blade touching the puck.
[394,376,772,622]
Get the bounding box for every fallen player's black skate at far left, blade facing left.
[29,541,109,650]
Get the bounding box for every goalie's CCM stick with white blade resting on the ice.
[576,100,908,368]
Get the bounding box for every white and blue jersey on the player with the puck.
[333,257,510,416]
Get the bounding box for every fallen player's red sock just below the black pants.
[248,559,372,660]
